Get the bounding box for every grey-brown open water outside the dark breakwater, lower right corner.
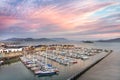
[77,50,120,80]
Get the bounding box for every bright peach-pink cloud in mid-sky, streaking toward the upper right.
[22,3,112,30]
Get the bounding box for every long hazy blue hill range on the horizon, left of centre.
[4,38,69,42]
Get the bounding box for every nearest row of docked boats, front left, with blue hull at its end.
[20,56,59,76]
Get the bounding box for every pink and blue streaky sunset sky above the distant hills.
[0,0,120,40]
